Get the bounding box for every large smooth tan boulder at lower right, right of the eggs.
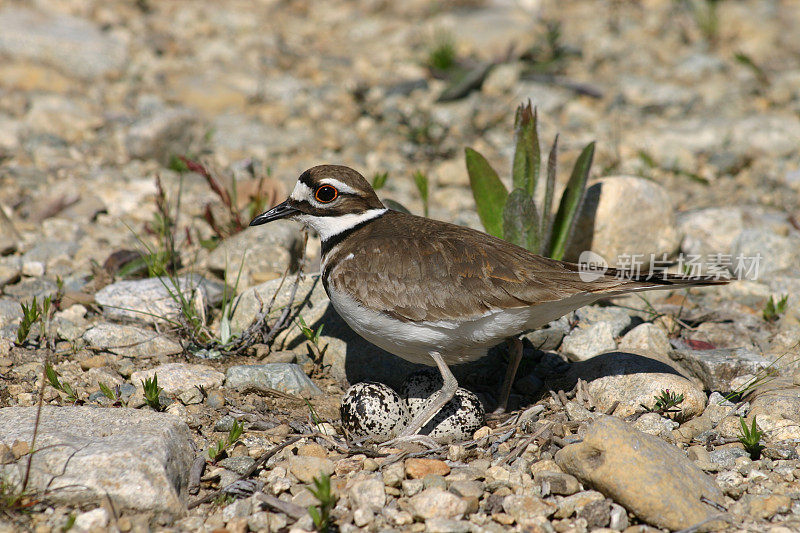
[555,416,725,530]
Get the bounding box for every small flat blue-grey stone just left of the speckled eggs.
[225,363,322,396]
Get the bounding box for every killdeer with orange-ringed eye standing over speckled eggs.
[250,165,727,438]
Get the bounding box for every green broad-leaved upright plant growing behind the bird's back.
[466,102,594,259]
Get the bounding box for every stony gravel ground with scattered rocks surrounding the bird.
[0,0,800,533]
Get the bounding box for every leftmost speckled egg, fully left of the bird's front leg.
[339,382,410,442]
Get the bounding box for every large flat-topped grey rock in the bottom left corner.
[0,406,195,514]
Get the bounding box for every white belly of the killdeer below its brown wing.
[328,287,596,365]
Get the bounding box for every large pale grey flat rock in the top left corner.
[0,7,128,79]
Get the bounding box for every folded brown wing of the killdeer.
[328,211,724,321]
